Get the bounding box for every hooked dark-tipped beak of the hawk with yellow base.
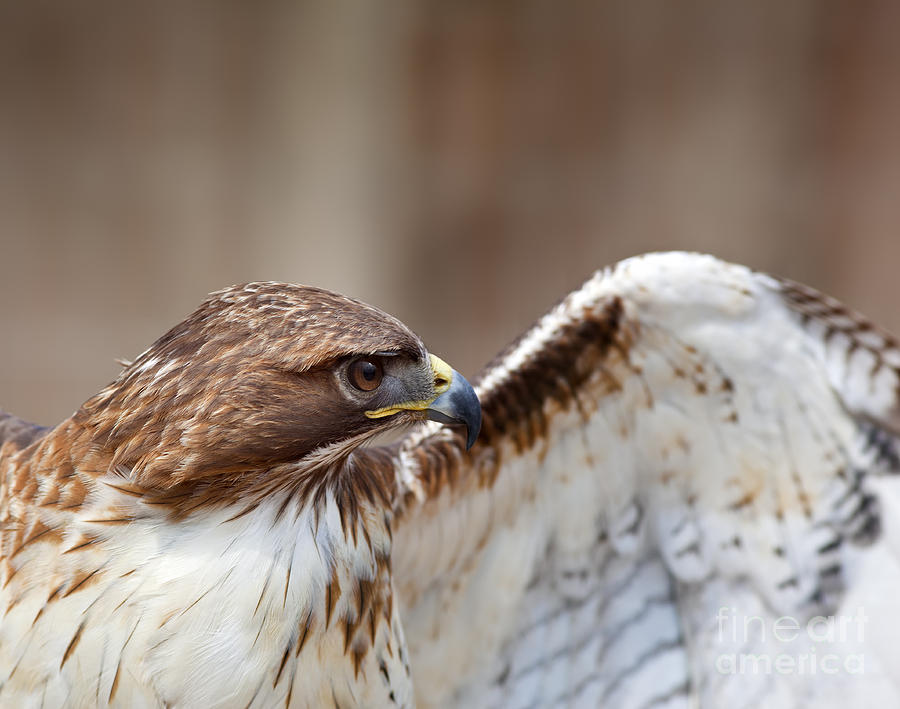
[366,355,481,450]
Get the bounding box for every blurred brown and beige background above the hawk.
[0,0,900,422]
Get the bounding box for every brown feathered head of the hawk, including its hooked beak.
[75,283,481,489]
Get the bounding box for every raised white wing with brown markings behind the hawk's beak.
[393,253,900,707]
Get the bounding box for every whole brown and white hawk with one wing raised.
[0,253,900,707]
